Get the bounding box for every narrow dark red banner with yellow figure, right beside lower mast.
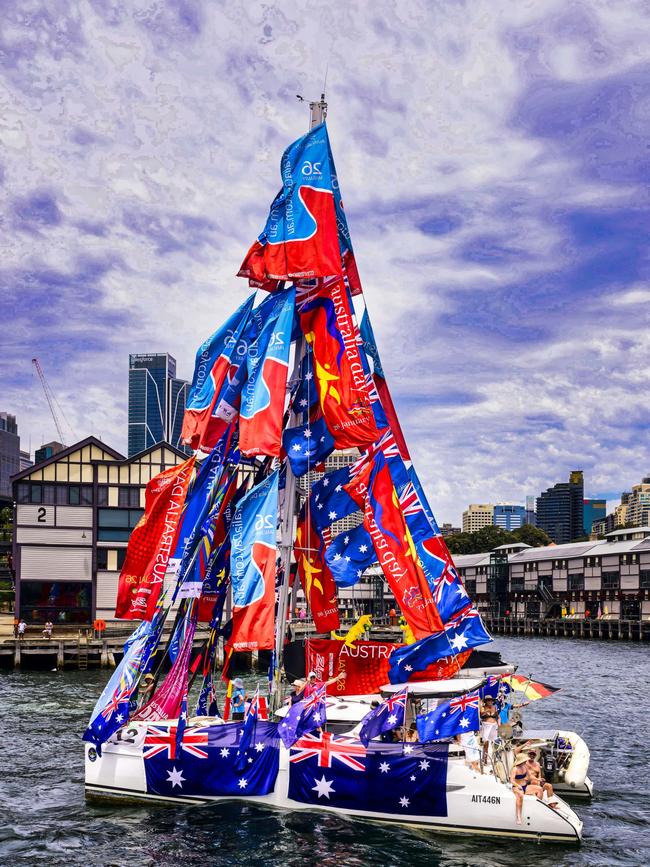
[293,504,340,632]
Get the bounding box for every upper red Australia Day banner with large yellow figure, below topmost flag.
[296,278,379,449]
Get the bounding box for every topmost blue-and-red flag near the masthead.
[239,123,341,286]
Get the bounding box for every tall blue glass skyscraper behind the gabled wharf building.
[128,352,189,457]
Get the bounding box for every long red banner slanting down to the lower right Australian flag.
[343,450,443,638]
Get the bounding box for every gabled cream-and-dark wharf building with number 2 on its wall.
[12,436,187,625]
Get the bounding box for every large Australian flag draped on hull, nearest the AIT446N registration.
[289,732,447,817]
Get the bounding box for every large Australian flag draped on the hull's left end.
[142,722,279,798]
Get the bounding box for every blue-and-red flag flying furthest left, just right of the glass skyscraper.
[182,294,255,448]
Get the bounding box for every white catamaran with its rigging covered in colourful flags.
[84,96,582,843]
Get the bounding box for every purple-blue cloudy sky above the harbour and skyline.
[0,0,650,522]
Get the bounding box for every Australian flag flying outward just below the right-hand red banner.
[388,604,492,683]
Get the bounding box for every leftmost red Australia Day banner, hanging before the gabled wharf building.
[115,456,195,620]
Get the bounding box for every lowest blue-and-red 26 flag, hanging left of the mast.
[229,470,279,650]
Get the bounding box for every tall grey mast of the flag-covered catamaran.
[271,93,327,710]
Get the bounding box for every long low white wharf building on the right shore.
[454,526,650,620]
